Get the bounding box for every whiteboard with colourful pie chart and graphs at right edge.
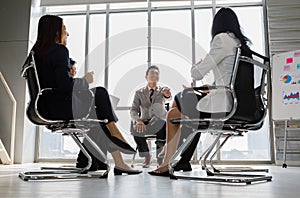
[272,50,300,120]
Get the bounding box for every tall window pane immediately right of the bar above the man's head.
[151,10,192,94]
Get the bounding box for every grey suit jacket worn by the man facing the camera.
[130,86,172,121]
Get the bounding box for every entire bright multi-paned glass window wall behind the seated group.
[39,0,270,160]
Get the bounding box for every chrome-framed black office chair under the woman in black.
[19,52,109,181]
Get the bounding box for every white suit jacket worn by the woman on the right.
[191,33,240,113]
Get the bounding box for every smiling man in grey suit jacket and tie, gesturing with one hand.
[130,65,172,168]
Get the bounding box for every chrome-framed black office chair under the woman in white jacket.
[169,47,272,184]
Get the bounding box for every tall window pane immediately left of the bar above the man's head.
[108,12,148,108]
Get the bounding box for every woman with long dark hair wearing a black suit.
[32,15,141,175]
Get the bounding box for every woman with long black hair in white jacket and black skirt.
[149,8,250,176]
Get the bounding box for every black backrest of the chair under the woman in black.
[21,51,57,125]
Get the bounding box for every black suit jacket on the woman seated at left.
[35,44,89,119]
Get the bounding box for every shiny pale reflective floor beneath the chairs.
[0,164,300,198]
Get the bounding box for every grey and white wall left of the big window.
[0,0,42,163]
